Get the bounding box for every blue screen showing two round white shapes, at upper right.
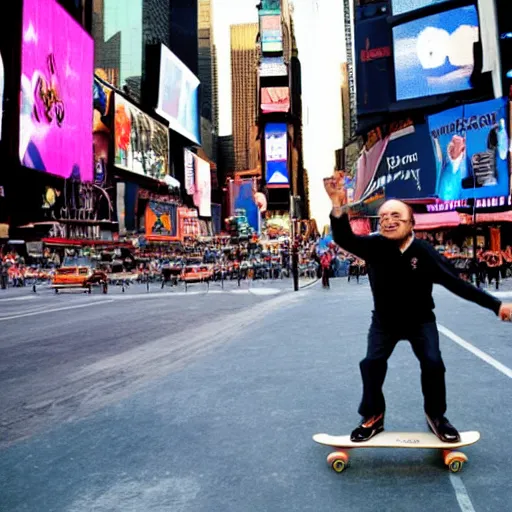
[393,5,479,101]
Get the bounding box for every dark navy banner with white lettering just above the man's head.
[367,123,436,199]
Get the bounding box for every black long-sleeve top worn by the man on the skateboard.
[331,214,501,323]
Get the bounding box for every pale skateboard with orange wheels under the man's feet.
[313,431,480,473]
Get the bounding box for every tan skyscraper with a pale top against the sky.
[231,23,259,171]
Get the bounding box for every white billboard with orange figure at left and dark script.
[114,93,169,180]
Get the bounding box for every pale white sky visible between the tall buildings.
[213,0,345,229]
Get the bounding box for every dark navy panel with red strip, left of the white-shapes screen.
[355,8,392,115]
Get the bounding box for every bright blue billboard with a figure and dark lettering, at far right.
[428,98,510,201]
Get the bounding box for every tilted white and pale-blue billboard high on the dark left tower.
[156,45,201,144]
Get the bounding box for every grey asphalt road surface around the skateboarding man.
[0,280,512,512]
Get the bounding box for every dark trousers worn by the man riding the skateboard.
[359,315,446,418]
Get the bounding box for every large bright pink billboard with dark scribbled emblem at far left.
[19,0,94,181]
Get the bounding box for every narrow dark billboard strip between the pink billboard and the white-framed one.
[92,77,113,184]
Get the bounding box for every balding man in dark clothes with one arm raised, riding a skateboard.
[324,177,512,443]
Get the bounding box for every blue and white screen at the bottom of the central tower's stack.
[265,123,290,187]
